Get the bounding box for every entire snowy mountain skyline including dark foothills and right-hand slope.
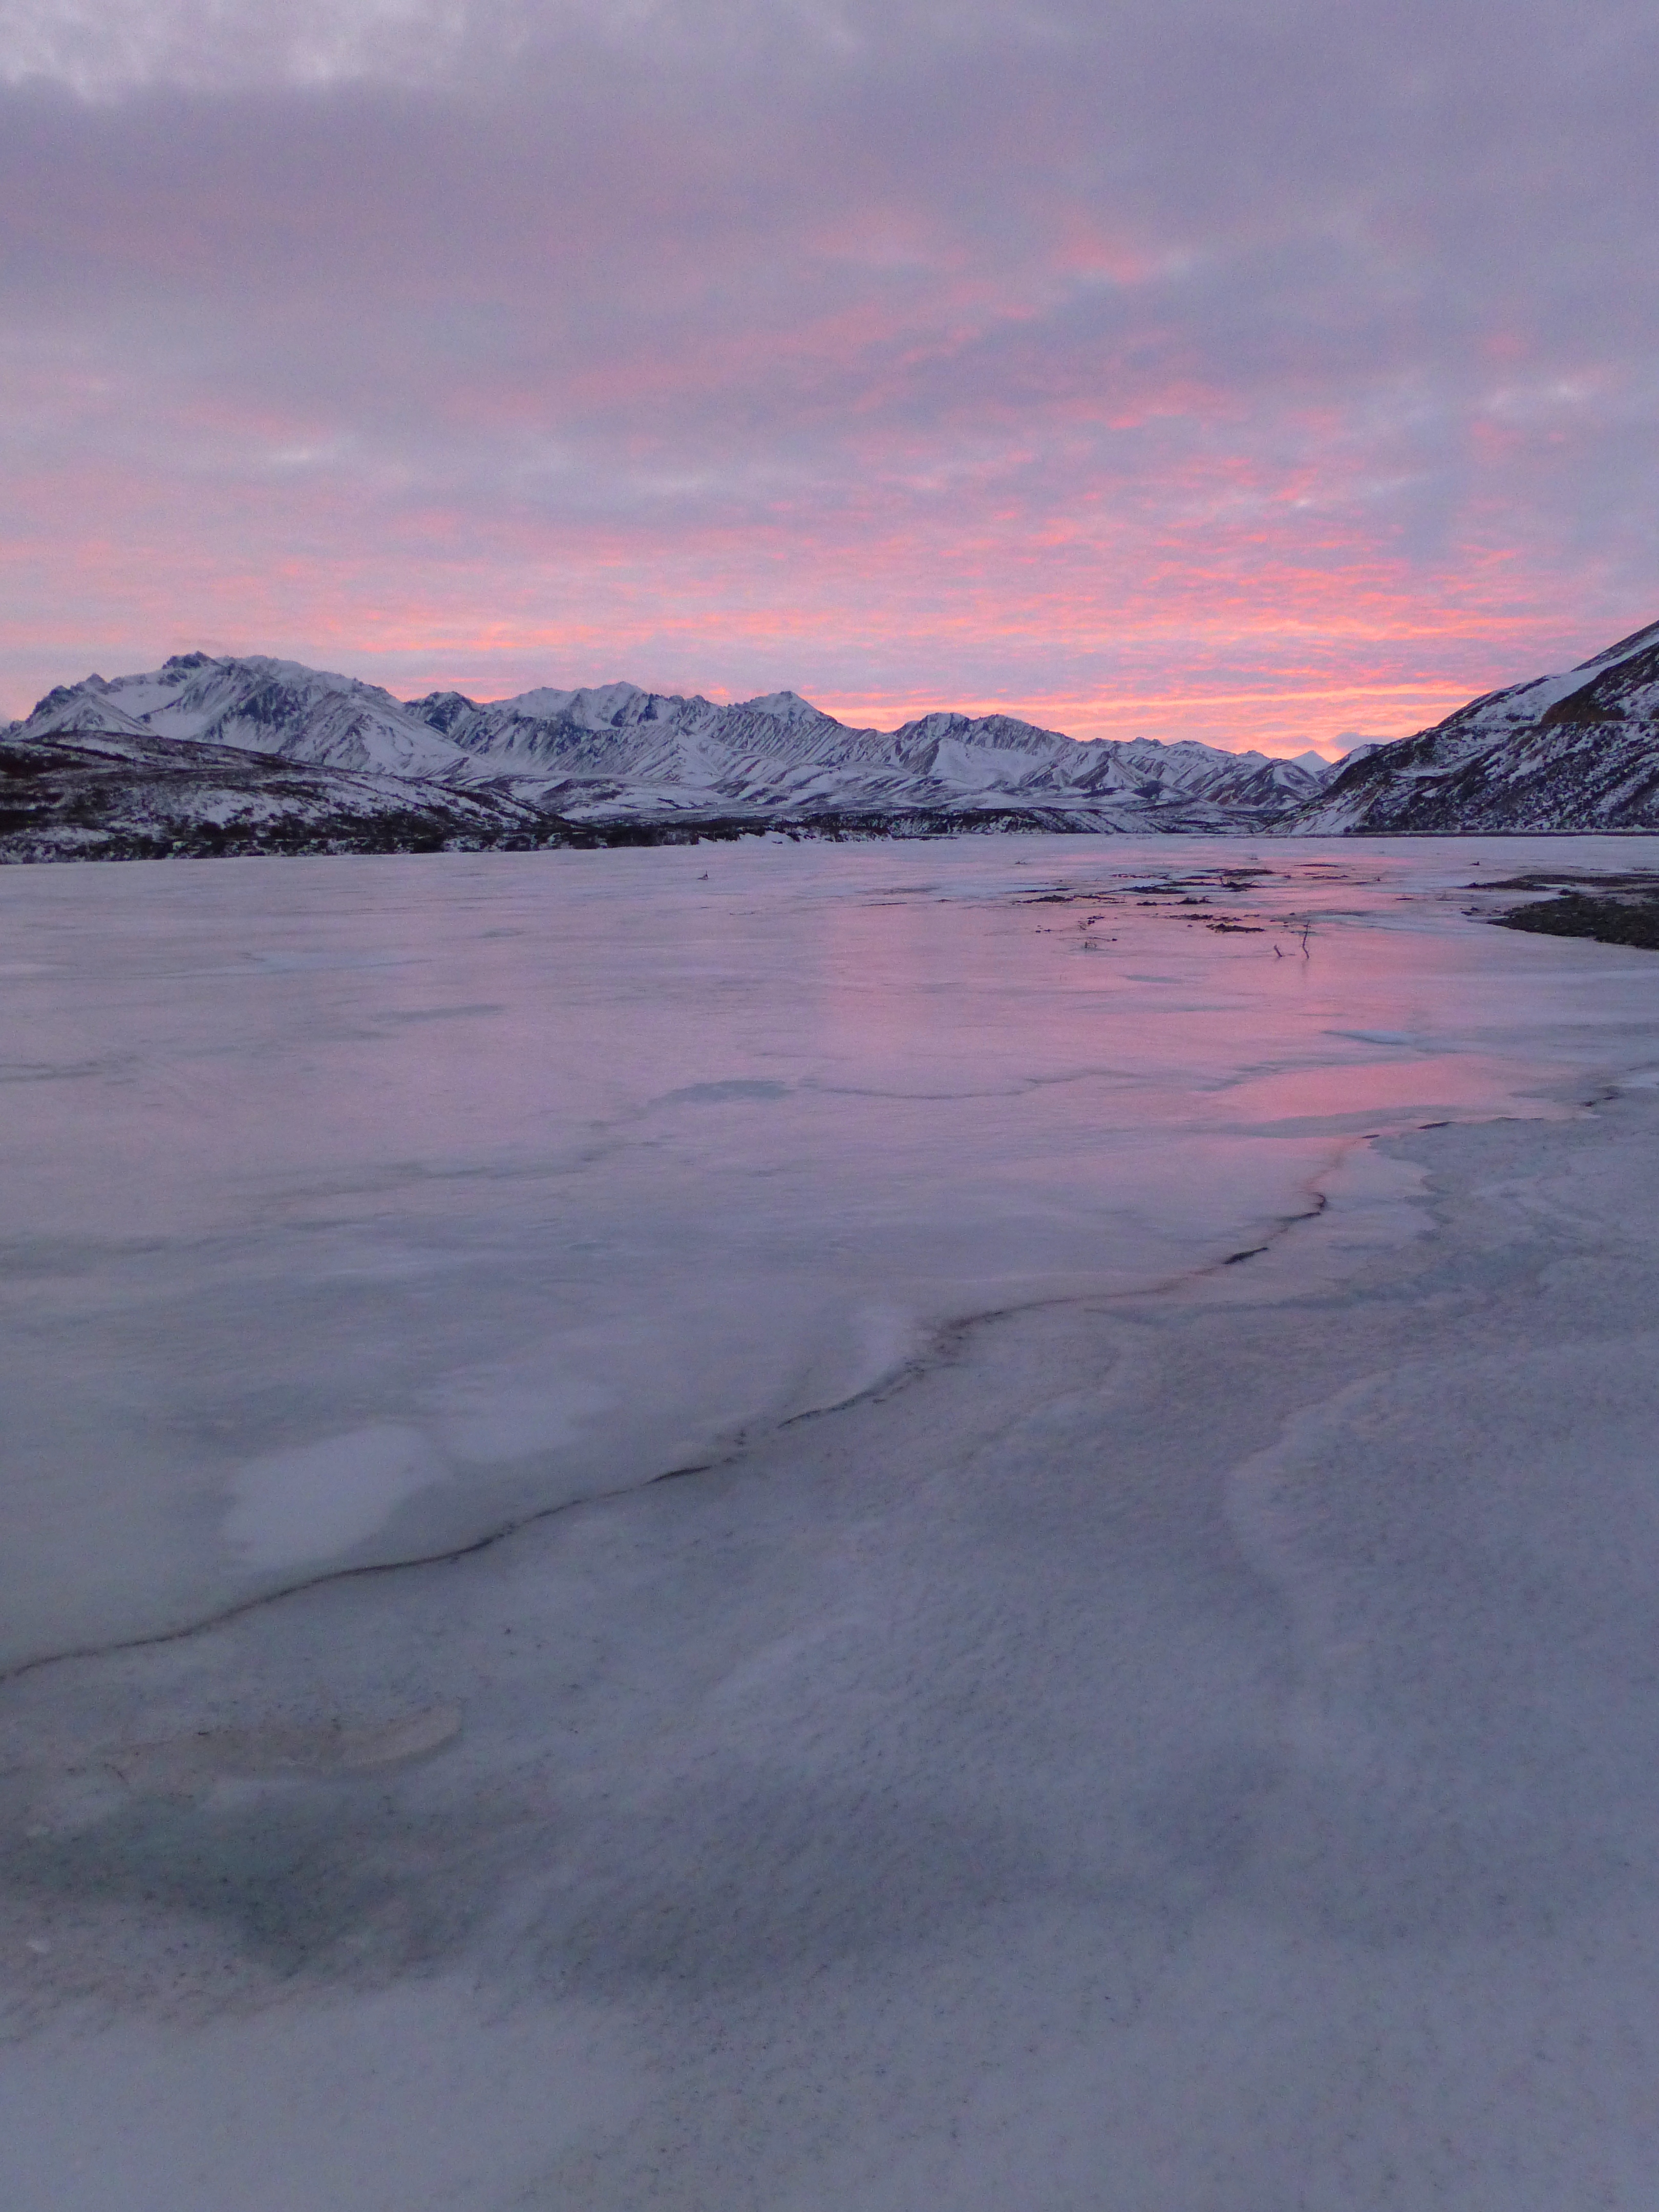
[0,624,1659,860]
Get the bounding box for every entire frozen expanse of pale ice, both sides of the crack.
[0,838,1659,2212]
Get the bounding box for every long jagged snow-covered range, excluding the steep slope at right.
[0,652,1325,858]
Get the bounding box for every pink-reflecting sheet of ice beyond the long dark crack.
[0,838,1654,1661]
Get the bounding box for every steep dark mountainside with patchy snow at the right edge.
[1285,622,1659,836]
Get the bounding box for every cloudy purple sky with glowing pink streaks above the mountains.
[0,0,1659,754]
